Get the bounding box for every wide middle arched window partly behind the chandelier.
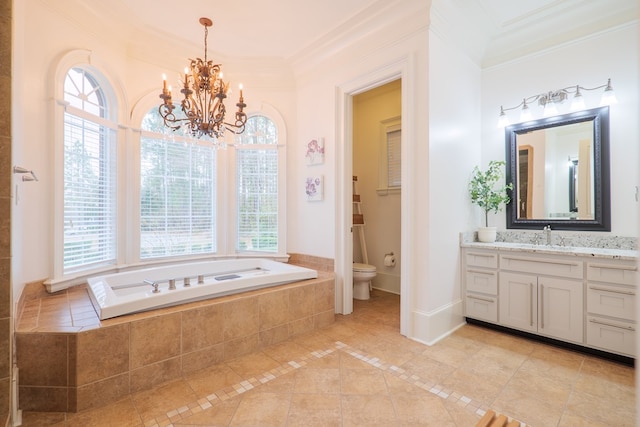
[140,108,217,259]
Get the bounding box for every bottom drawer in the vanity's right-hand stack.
[587,316,636,356]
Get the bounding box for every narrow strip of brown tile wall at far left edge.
[0,0,12,425]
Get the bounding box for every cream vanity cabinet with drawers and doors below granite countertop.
[462,246,637,357]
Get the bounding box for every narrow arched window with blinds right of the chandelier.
[236,116,278,252]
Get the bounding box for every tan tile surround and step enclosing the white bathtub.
[16,271,335,412]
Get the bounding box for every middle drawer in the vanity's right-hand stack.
[587,282,636,320]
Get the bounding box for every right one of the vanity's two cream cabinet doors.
[538,277,584,344]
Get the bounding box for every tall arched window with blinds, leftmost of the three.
[63,68,116,273]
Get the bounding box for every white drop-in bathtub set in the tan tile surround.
[87,258,318,320]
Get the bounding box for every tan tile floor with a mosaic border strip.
[18,291,635,427]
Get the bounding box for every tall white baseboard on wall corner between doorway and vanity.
[409,300,465,345]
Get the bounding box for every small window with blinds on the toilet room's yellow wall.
[378,117,402,195]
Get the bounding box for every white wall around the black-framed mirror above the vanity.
[482,23,640,237]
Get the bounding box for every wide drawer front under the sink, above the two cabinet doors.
[500,255,584,279]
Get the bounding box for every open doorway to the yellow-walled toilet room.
[352,79,402,299]
